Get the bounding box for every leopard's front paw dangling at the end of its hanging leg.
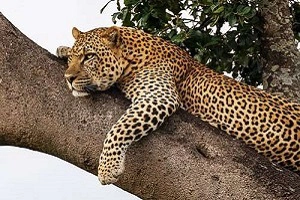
[98,153,125,185]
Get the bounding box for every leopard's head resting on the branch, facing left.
[65,27,126,97]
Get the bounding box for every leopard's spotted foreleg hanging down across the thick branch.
[98,68,179,184]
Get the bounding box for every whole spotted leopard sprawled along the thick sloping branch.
[57,26,300,185]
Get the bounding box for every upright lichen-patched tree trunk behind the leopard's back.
[259,0,300,102]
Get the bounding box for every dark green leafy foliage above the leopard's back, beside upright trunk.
[102,0,300,85]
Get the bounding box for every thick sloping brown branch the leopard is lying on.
[0,13,300,200]
